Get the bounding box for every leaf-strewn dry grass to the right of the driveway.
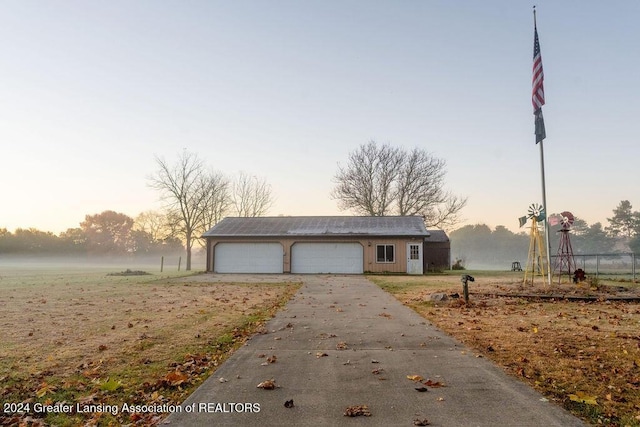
[372,272,640,426]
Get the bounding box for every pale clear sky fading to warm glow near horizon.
[0,0,640,233]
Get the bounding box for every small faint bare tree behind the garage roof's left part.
[232,172,273,217]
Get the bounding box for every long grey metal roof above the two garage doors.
[202,216,429,237]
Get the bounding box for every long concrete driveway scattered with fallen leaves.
[164,275,585,427]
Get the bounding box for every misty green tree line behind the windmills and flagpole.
[449,200,640,268]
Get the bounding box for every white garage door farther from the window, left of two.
[213,243,283,273]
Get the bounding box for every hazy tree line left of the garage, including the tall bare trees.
[0,150,273,260]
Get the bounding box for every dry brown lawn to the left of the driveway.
[0,271,299,425]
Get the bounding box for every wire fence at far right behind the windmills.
[551,253,640,281]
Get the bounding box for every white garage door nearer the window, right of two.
[291,243,364,274]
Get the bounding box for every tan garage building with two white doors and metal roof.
[202,216,430,274]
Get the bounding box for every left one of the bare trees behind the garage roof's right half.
[331,141,400,216]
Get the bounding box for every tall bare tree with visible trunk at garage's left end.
[149,150,222,270]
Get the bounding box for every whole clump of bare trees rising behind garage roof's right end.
[332,141,467,228]
